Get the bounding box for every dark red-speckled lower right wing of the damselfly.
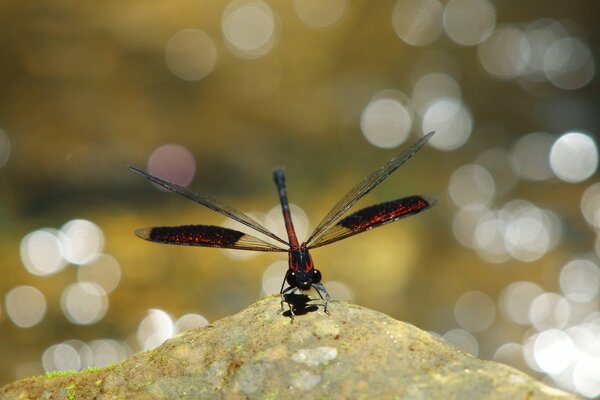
[308,196,435,249]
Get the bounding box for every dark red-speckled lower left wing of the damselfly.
[135,225,287,251]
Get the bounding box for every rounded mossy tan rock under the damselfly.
[0,296,575,400]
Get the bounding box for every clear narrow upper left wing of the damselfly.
[129,166,289,246]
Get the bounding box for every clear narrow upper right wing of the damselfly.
[306,132,433,247]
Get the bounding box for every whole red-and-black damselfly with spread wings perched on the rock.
[129,132,436,318]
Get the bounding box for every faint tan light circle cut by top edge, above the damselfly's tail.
[292,0,348,29]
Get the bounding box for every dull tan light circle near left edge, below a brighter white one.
[4,286,47,328]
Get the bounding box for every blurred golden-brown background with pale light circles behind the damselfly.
[0,0,600,398]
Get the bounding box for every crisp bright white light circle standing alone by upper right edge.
[550,132,598,183]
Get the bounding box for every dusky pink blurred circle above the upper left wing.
[148,144,196,186]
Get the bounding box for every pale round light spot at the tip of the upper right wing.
[422,97,473,151]
